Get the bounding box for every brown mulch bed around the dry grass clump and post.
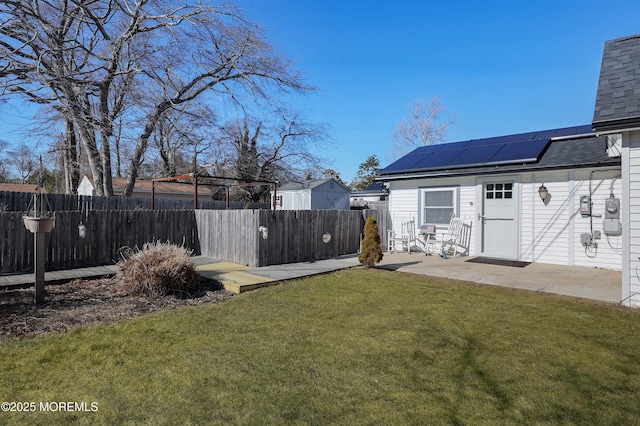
[0,279,233,342]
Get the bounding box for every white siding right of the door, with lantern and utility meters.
[520,168,622,270]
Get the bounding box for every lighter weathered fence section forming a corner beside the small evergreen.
[196,210,388,267]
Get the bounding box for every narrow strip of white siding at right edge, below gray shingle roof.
[621,132,640,307]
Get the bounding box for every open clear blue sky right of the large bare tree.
[236,0,640,182]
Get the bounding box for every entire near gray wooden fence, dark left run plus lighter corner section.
[0,210,388,273]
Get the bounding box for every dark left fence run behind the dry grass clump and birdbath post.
[0,210,200,273]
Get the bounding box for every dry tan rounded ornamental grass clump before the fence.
[116,241,199,297]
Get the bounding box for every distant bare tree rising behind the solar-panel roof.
[392,97,453,159]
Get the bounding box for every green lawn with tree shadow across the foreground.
[0,269,640,425]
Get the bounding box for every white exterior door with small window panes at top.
[479,180,518,259]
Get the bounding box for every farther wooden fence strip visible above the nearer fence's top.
[0,191,271,211]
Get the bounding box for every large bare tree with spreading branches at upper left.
[0,0,311,195]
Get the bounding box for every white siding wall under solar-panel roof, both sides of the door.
[389,168,620,272]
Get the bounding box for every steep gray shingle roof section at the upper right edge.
[593,35,640,131]
